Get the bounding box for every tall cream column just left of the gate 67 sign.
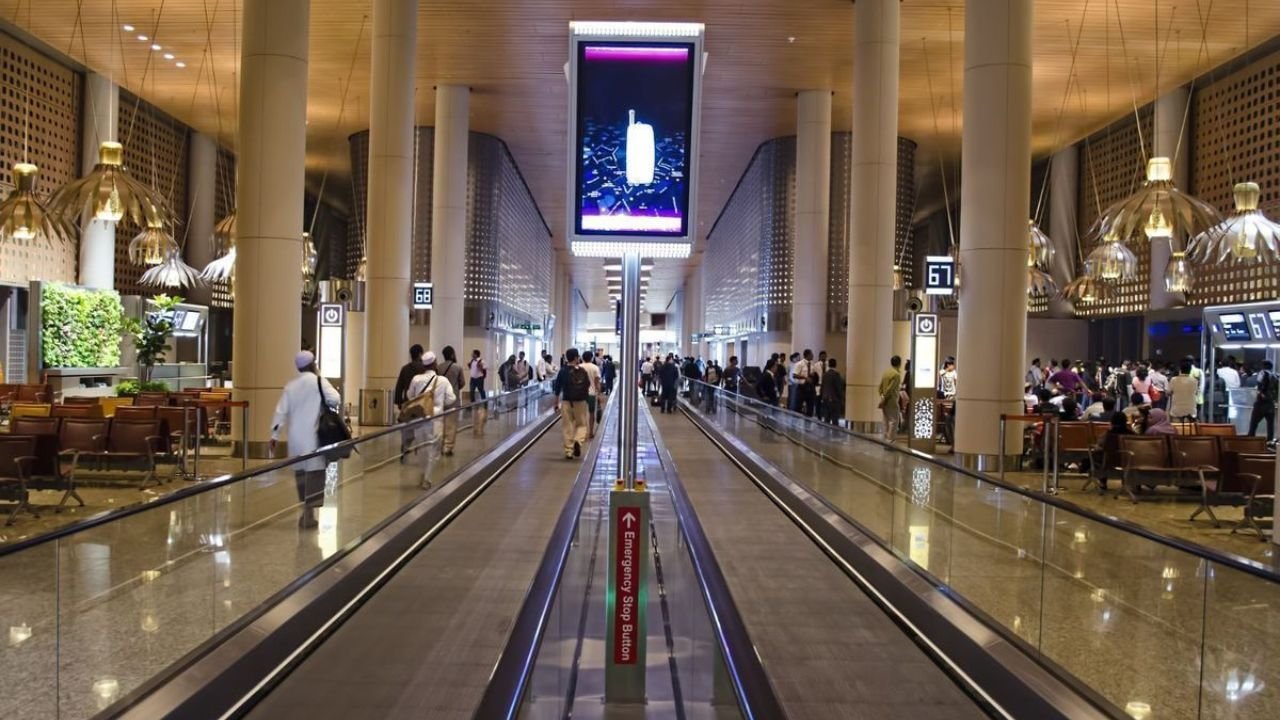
[845,0,900,429]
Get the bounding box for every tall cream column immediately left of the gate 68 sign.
[364,0,417,389]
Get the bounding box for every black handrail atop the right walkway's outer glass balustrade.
[690,380,1280,584]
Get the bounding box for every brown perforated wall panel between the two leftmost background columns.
[115,88,189,296]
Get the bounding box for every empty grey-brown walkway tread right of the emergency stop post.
[655,415,986,720]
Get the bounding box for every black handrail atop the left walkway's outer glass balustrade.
[0,383,547,557]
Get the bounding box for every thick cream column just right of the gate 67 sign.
[955,0,1032,458]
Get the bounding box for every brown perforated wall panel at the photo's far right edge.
[1187,53,1280,305]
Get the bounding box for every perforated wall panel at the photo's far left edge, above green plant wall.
[0,33,81,283]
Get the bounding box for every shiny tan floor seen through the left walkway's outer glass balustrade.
[0,401,547,719]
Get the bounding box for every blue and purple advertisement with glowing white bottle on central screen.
[575,41,696,237]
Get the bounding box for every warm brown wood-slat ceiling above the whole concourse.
[0,0,1280,311]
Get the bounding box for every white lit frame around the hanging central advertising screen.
[564,23,705,256]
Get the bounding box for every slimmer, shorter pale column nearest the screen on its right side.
[791,90,831,357]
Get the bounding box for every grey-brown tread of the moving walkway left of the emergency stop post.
[250,428,579,720]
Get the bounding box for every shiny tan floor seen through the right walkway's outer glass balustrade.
[691,394,1280,719]
